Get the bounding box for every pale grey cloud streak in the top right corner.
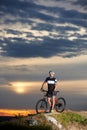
[35,0,87,13]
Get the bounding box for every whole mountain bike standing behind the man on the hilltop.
[35,90,66,114]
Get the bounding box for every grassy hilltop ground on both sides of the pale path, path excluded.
[0,110,87,130]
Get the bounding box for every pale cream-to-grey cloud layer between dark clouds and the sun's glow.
[0,55,87,83]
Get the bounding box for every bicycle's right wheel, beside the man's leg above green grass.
[55,97,66,112]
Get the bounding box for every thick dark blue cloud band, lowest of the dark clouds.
[0,37,87,58]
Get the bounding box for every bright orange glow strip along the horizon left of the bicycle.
[0,109,36,116]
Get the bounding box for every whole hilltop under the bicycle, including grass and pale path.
[0,110,87,130]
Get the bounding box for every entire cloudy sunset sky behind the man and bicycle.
[0,0,87,114]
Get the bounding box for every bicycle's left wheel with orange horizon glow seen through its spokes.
[36,99,47,114]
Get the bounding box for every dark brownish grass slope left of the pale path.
[0,114,52,130]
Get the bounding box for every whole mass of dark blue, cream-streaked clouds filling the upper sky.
[0,0,87,58]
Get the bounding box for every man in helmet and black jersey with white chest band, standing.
[41,70,57,112]
